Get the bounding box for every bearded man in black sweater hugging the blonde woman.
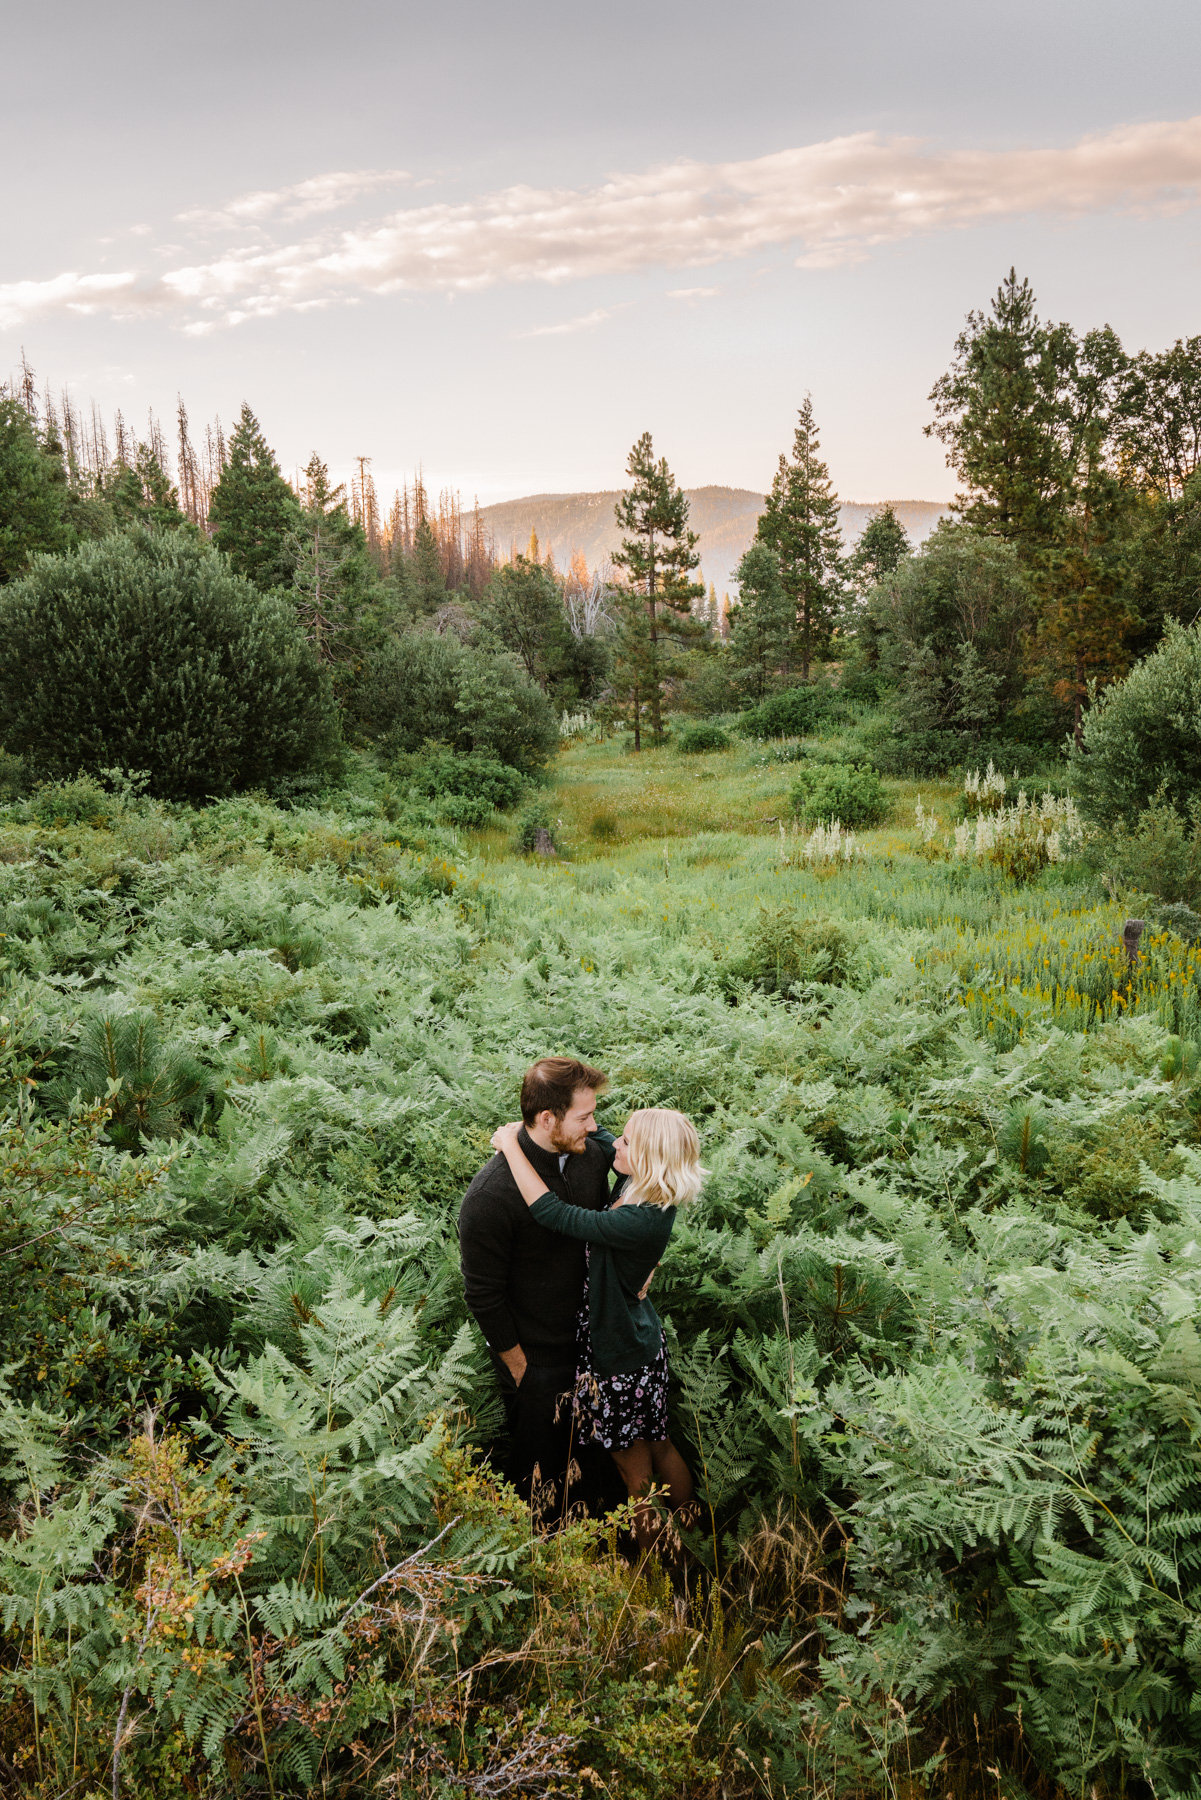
[459,1057,614,1517]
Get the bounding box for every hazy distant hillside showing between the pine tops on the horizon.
[481,488,947,594]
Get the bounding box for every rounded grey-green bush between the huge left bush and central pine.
[357,632,558,770]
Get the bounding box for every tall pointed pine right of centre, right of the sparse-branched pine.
[758,394,846,680]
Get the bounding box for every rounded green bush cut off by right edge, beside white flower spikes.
[1071,621,1201,826]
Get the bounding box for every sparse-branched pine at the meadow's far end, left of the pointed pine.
[612,432,704,751]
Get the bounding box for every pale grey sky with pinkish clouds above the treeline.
[0,0,1201,504]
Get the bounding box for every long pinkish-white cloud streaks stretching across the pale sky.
[0,117,1201,335]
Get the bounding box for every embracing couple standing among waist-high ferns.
[459,1057,706,1548]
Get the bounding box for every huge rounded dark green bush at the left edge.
[0,531,339,801]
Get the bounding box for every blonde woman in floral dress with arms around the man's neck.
[492,1107,708,1550]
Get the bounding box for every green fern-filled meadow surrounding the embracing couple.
[11,727,1201,1800]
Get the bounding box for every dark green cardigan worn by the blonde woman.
[529,1193,675,1375]
